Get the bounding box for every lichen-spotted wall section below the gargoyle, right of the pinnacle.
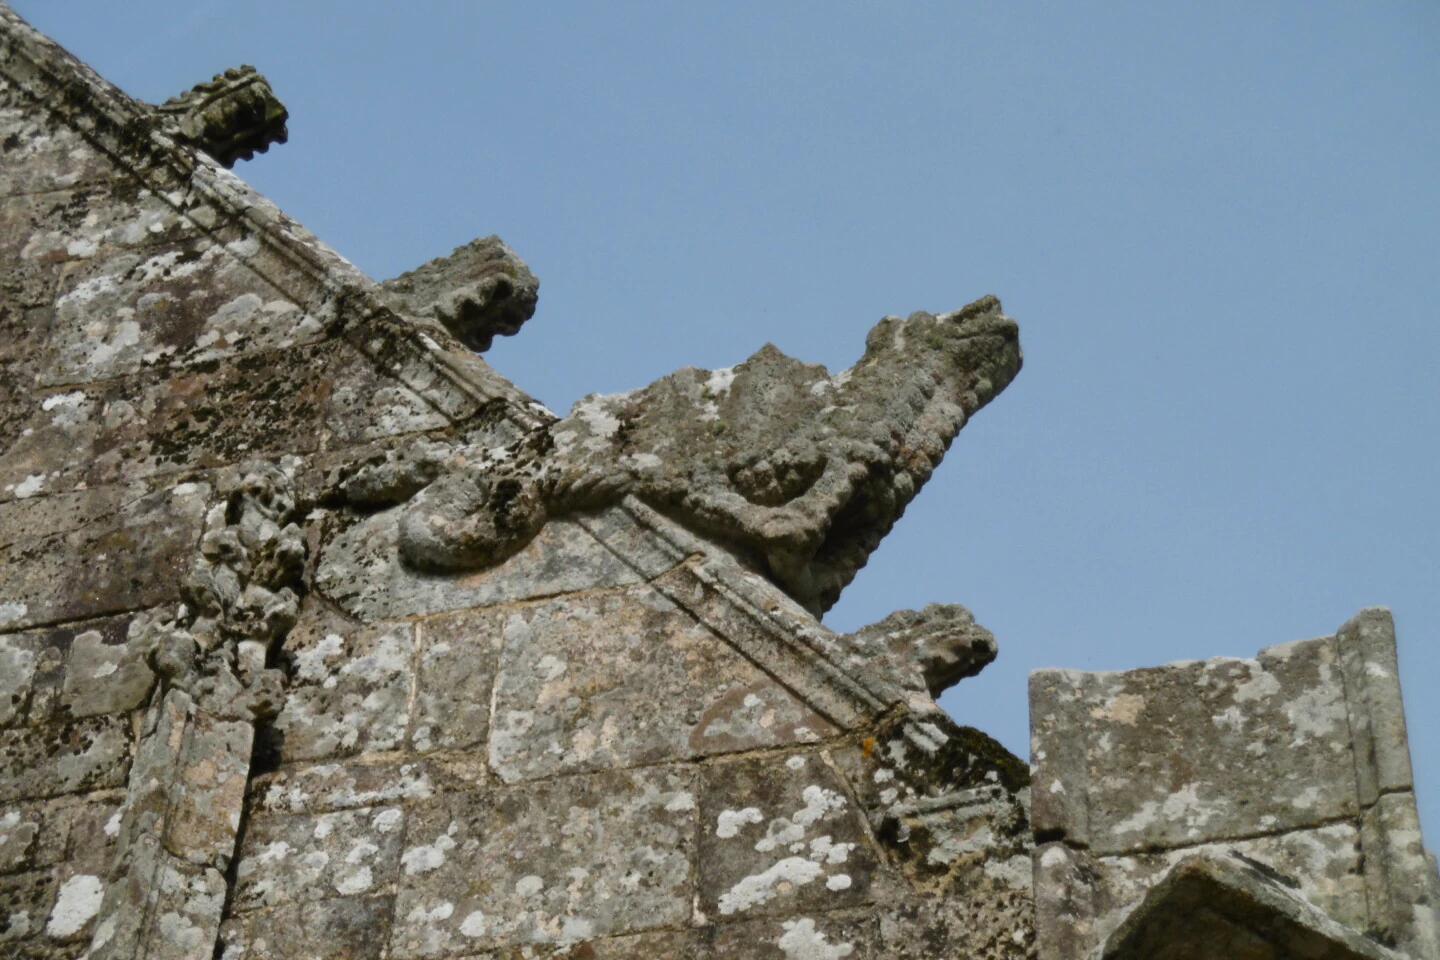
[225,502,1031,959]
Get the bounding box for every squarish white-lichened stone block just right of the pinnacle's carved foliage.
[272,599,415,761]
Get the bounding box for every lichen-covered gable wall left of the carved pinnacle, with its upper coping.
[0,7,529,957]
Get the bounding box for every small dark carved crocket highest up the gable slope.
[156,65,289,167]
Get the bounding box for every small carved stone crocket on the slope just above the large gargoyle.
[380,236,540,353]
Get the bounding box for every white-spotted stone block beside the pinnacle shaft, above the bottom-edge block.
[230,806,405,913]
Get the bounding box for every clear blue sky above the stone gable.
[12,0,1440,845]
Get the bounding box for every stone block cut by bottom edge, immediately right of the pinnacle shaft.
[219,895,395,960]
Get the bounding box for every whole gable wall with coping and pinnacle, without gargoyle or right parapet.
[0,4,1034,960]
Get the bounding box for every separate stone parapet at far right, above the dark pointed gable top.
[1031,607,1440,959]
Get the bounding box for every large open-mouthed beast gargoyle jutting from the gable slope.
[400,296,1021,613]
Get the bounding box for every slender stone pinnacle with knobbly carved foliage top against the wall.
[86,462,307,960]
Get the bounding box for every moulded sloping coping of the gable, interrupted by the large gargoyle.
[0,0,956,740]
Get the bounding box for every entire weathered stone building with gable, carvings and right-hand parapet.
[0,3,1440,960]
